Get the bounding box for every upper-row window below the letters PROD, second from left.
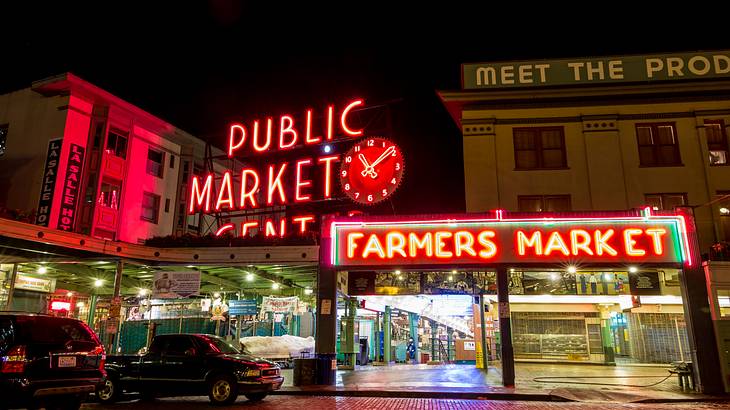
[636,122,682,167]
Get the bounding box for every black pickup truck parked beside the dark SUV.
[96,334,284,405]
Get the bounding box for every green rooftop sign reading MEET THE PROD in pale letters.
[462,50,730,90]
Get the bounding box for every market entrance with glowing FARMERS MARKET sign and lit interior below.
[317,209,711,386]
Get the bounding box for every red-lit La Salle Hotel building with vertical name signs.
[0,73,230,243]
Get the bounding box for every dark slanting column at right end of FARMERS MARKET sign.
[677,207,725,394]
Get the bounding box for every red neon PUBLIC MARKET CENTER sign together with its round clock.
[187,99,403,238]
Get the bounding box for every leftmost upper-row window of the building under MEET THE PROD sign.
[512,127,567,169]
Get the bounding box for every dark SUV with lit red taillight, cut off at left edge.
[0,312,106,409]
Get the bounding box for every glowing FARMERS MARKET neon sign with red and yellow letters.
[324,208,689,268]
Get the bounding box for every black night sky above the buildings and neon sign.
[0,1,730,213]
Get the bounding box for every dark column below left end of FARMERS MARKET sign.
[314,260,337,385]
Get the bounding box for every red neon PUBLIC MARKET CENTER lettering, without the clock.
[188,99,364,237]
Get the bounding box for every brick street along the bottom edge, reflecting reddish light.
[83,396,730,410]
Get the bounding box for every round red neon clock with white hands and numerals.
[340,138,405,205]
